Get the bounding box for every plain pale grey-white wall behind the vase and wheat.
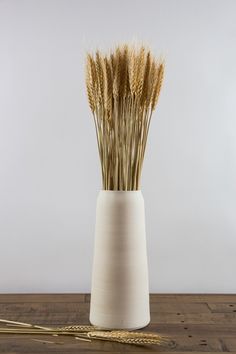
[0,0,236,293]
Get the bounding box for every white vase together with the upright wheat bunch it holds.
[86,45,164,329]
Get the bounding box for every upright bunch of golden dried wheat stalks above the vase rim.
[86,45,164,191]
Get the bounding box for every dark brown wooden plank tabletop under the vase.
[0,294,236,354]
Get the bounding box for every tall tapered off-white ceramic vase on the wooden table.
[90,191,150,330]
